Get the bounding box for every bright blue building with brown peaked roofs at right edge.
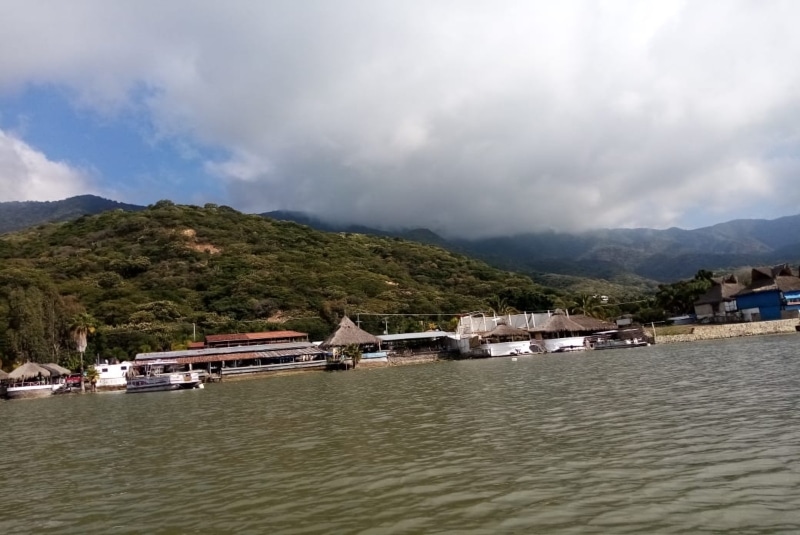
[736,264,800,321]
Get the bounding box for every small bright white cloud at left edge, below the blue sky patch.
[0,130,95,201]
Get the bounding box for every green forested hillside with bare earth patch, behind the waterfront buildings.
[0,201,555,368]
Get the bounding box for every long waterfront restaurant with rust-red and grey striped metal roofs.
[134,331,326,379]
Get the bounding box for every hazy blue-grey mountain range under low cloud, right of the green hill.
[263,212,800,286]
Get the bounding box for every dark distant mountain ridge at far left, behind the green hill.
[0,195,144,234]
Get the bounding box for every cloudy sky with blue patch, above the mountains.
[0,0,800,237]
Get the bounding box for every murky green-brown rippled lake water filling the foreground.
[0,335,800,534]
